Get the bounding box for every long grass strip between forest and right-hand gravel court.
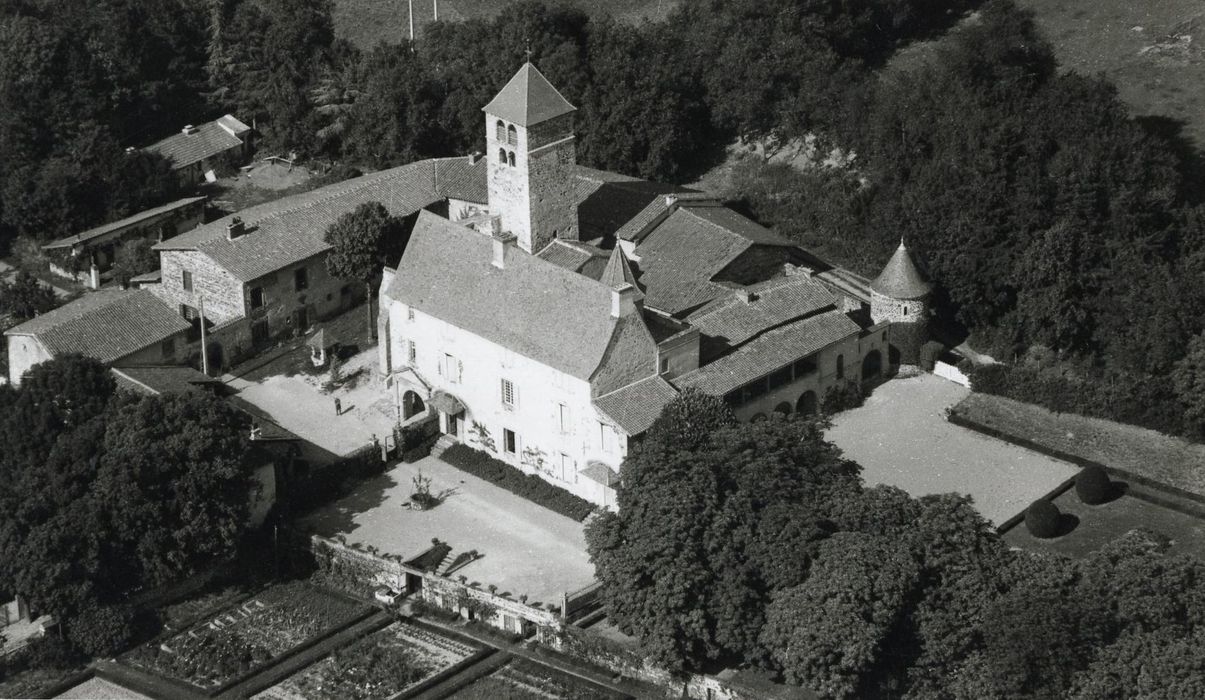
[954,394,1205,496]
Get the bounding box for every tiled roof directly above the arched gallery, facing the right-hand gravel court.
[674,311,860,396]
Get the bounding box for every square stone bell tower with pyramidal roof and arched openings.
[482,63,577,253]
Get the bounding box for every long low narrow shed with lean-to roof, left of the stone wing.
[42,196,205,289]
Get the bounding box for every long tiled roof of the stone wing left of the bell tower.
[154,159,484,282]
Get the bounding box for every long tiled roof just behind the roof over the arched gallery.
[687,275,836,347]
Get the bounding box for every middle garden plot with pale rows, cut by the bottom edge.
[254,622,480,700]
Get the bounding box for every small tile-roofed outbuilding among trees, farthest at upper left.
[143,114,251,187]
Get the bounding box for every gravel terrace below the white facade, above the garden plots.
[302,457,594,605]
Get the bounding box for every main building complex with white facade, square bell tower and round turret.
[378,63,928,507]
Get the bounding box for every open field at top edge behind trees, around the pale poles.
[334,0,680,48]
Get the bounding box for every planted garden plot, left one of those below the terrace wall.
[122,581,368,689]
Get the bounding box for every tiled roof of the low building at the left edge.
[5,289,190,363]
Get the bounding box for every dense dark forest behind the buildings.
[0,0,1205,439]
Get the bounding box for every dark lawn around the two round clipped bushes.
[1004,489,1205,557]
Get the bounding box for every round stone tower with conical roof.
[870,240,933,364]
